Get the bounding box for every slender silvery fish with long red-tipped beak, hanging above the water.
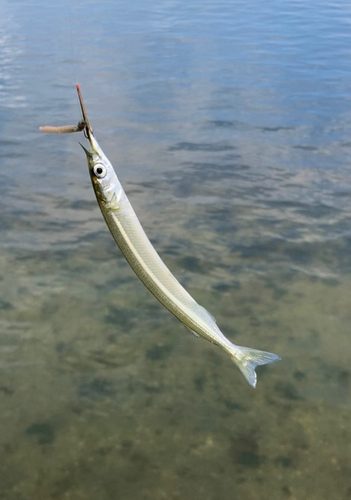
[42,84,281,387]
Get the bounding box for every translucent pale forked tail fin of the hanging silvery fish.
[230,344,281,387]
